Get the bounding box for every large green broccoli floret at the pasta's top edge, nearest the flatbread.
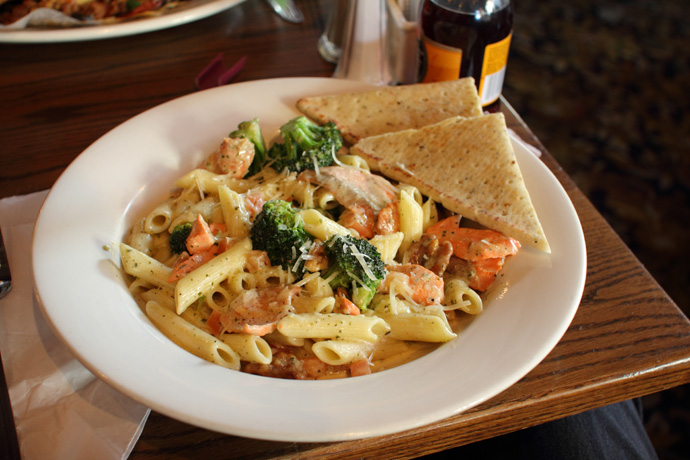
[268,116,343,172]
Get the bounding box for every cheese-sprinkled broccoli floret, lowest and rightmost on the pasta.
[322,235,386,310]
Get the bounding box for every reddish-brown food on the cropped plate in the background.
[0,0,184,26]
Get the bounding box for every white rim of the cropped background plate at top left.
[0,0,244,43]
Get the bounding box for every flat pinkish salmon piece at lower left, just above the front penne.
[220,286,300,336]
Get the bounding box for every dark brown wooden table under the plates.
[0,0,690,459]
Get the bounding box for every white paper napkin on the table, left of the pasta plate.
[0,191,149,460]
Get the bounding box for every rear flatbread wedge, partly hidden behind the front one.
[297,77,482,144]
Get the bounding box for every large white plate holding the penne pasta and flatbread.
[33,78,586,442]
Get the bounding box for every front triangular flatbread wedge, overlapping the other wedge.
[350,113,550,252]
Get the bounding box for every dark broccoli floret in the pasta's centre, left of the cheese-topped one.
[250,200,312,275]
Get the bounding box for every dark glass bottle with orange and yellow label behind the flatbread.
[420,0,513,111]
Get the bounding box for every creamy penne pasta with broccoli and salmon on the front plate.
[120,109,520,379]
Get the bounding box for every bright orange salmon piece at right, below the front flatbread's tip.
[426,216,520,260]
